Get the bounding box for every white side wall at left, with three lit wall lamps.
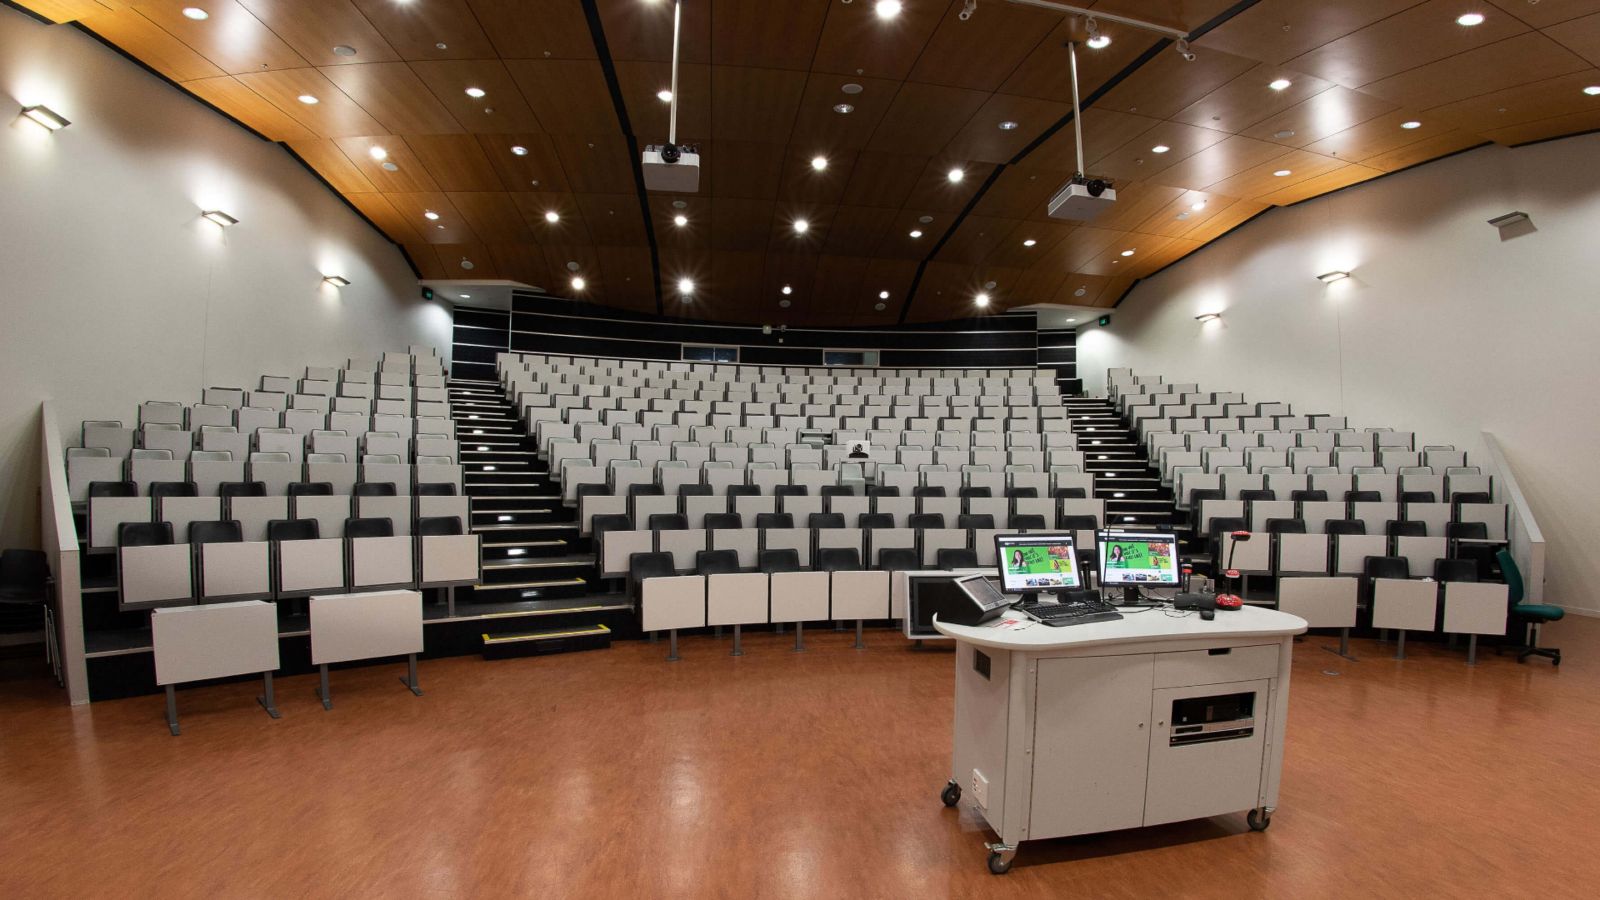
[0,6,450,546]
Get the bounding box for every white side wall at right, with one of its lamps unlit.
[1078,135,1600,610]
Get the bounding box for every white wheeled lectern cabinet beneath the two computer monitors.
[934,607,1307,874]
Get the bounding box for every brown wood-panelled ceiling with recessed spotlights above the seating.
[22,0,1600,325]
